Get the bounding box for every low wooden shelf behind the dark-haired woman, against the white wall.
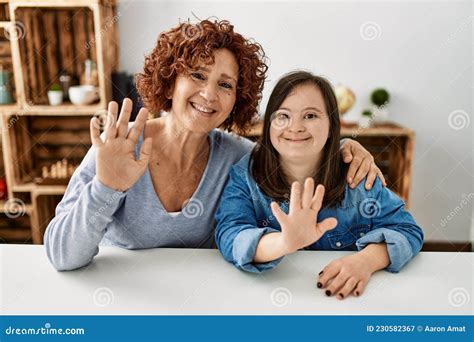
[247,122,415,207]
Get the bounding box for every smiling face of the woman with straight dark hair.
[270,84,330,165]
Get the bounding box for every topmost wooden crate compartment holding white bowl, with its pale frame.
[10,0,119,111]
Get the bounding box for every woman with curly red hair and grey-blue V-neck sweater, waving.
[45,20,386,270]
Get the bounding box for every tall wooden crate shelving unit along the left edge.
[0,0,118,244]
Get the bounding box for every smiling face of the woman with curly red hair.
[170,49,239,133]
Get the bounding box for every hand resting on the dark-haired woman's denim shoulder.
[341,139,387,190]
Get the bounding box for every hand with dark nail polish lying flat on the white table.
[317,252,374,299]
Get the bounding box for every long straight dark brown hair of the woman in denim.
[251,71,347,207]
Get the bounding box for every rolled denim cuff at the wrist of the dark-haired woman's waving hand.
[232,228,283,273]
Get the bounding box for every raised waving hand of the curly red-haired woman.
[90,98,152,191]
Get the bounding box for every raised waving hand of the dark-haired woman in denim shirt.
[271,178,337,254]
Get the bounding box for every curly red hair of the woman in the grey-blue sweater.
[136,20,268,134]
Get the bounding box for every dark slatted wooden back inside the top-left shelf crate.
[15,7,97,106]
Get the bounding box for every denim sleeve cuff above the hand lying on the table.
[356,228,413,273]
